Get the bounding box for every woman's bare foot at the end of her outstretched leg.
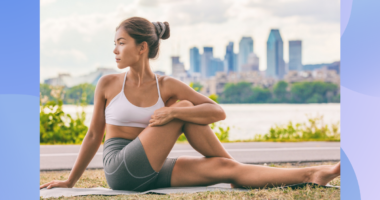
[307,162,340,185]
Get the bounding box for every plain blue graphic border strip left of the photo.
[0,0,40,199]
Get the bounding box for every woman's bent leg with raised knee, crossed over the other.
[138,100,232,172]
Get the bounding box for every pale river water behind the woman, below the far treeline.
[63,103,340,140]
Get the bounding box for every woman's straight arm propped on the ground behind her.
[40,76,110,189]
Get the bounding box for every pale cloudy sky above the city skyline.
[40,0,340,82]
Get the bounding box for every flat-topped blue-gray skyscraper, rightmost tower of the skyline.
[289,40,302,71]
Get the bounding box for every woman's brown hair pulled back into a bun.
[116,17,170,58]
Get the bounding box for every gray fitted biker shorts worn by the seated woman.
[103,137,177,191]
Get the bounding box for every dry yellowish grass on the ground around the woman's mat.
[40,162,340,200]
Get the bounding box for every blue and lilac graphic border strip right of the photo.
[341,0,380,200]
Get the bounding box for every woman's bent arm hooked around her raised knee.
[163,76,226,124]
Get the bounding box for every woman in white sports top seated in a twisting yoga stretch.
[40,17,340,191]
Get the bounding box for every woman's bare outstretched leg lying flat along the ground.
[171,156,340,188]
